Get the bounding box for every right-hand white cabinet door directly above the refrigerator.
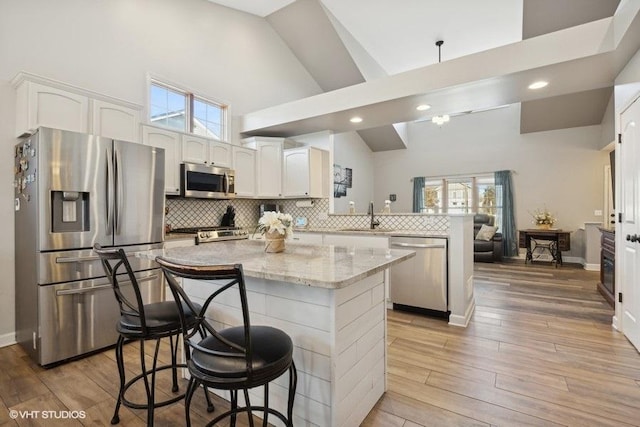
[91,100,140,142]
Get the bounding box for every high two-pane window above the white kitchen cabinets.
[149,80,227,141]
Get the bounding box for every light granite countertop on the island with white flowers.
[137,240,415,289]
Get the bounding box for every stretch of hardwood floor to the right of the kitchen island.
[363,262,640,427]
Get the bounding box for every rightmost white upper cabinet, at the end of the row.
[282,147,329,198]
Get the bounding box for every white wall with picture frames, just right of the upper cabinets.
[331,132,372,214]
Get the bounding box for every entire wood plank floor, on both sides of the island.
[0,262,640,427]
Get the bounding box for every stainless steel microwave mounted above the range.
[180,163,236,199]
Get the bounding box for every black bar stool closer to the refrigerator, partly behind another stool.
[93,244,214,426]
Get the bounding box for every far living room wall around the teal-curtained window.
[373,105,608,257]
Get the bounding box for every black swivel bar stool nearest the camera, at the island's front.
[156,257,297,427]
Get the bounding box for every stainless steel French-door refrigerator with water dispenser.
[14,128,165,365]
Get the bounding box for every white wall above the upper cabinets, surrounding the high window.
[0,0,320,345]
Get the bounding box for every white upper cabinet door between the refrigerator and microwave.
[142,126,181,194]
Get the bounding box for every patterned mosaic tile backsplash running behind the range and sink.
[165,198,449,233]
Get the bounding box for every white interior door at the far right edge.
[616,98,640,350]
